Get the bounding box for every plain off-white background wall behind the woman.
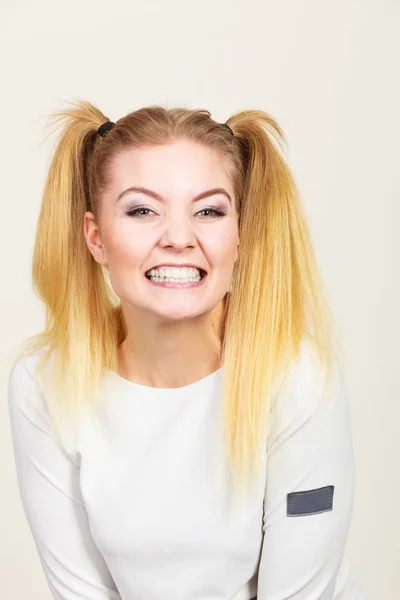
[0,0,400,600]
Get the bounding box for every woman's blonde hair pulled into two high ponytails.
[10,101,342,502]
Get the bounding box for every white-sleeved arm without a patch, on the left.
[7,356,121,600]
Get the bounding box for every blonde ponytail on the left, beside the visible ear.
[12,102,123,451]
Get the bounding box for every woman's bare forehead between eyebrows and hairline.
[106,139,231,191]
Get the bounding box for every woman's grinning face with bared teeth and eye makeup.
[84,140,239,320]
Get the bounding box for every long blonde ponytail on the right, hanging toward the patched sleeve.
[217,110,340,500]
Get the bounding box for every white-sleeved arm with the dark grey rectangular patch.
[258,348,354,600]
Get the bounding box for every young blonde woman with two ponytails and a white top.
[8,102,363,600]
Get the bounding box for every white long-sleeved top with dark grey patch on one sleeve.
[8,346,364,600]
